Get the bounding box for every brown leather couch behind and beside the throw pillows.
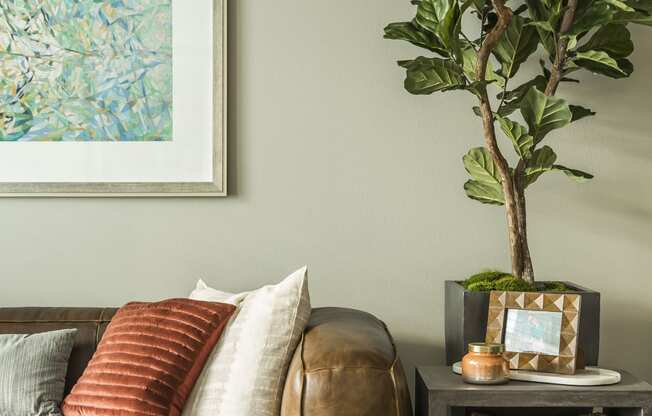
[0,308,412,416]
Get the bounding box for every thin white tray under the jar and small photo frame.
[453,362,620,386]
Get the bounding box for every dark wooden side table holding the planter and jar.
[415,366,652,416]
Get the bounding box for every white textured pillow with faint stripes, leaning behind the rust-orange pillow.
[183,267,311,416]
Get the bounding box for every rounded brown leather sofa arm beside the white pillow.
[281,308,412,416]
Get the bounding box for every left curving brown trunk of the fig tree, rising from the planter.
[476,0,523,278]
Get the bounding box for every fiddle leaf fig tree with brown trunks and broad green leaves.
[385,0,652,284]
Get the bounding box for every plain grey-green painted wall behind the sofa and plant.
[0,0,652,386]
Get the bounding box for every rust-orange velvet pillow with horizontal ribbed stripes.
[63,299,235,416]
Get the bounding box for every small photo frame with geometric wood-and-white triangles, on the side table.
[486,291,582,374]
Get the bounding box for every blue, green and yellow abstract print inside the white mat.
[0,0,172,141]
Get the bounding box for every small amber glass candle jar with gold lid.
[462,343,509,384]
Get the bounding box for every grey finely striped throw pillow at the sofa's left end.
[0,329,77,416]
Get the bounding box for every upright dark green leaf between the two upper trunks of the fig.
[493,16,539,78]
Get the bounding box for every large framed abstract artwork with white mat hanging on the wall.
[0,0,227,197]
